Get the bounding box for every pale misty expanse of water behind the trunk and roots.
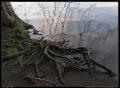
[11,2,118,75]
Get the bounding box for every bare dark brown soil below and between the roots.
[2,59,118,87]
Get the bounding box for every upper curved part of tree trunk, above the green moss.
[1,1,33,27]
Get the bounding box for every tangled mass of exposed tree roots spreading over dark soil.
[3,39,115,85]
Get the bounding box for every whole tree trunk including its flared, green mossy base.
[1,1,33,61]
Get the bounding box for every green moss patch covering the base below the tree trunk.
[1,23,29,56]
